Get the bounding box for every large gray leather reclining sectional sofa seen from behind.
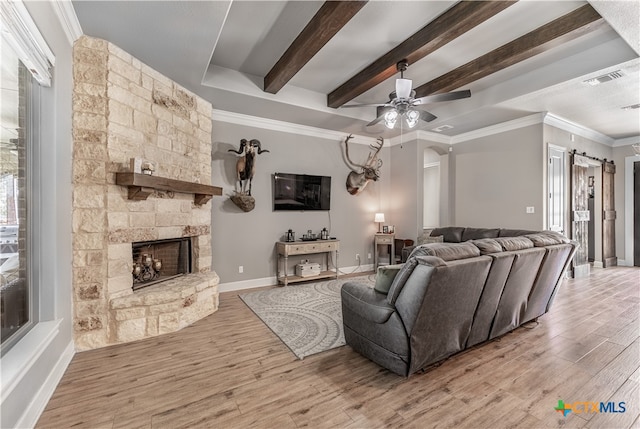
[341,227,577,376]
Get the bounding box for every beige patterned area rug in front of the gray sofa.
[240,275,375,359]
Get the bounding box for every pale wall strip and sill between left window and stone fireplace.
[0,2,74,428]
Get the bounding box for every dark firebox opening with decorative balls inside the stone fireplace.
[131,237,192,291]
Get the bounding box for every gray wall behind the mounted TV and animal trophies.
[212,121,393,290]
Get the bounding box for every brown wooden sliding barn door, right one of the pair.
[602,161,618,268]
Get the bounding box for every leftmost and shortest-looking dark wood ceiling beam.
[264,0,368,94]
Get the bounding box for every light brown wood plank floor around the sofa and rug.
[37,267,640,429]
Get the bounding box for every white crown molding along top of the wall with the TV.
[211,109,376,145]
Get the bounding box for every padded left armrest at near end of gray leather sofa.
[340,282,395,323]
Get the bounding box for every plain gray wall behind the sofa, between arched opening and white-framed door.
[450,125,544,229]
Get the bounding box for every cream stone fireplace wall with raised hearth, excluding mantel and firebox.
[73,36,218,350]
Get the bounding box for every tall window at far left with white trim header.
[0,2,53,355]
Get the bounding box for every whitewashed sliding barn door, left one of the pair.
[571,153,590,278]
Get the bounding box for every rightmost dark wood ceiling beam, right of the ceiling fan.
[415,4,605,98]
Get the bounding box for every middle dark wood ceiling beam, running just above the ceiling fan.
[327,1,515,108]
